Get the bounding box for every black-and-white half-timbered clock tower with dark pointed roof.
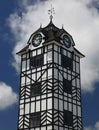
[17,9,84,130]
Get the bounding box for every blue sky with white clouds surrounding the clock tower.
[0,0,99,130]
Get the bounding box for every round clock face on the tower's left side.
[32,33,42,47]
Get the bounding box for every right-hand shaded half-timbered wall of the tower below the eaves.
[53,45,82,130]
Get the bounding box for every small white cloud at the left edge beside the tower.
[0,82,18,110]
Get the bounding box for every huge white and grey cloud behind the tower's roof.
[8,0,99,93]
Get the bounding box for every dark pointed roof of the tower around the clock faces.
[17,21,84,58]
